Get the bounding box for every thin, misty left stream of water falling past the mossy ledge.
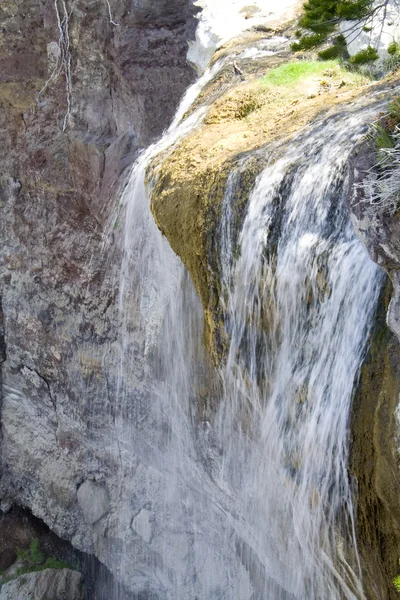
[114,57,260,600]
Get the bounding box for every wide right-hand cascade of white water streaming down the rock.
[214,111,381,600]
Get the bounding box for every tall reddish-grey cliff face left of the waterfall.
[0,0,196,592]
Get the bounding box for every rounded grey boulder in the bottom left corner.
[0,569,84,600]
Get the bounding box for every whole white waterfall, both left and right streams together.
[115,31,382,600]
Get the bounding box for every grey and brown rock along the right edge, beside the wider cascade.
[348,122,400,600]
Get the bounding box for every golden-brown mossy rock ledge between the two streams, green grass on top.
[147,50,396,362]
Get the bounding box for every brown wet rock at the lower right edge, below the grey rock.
[350,282,400,600]
